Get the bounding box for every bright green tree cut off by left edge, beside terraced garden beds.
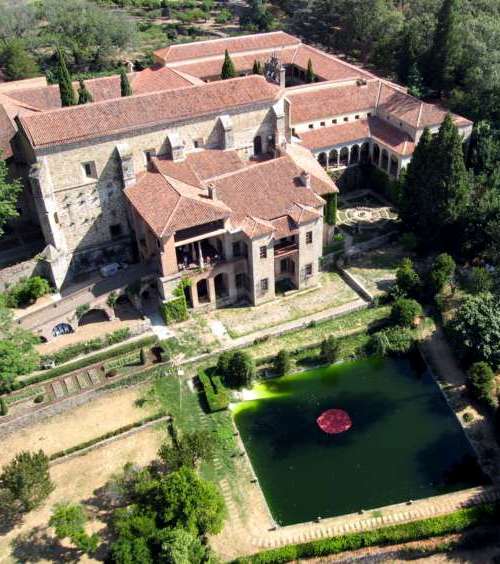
[0,305,39,392]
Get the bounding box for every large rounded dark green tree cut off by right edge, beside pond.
[449,294,500,370]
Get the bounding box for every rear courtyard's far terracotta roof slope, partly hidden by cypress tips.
[172,47,296,78]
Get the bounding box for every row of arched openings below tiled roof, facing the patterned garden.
[315,141,401,178]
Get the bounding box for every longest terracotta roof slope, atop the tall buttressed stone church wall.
[21,76,280,147]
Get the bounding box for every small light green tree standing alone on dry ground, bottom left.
[49,503,100,554]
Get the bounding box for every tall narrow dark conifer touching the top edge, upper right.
[429,0,461,93]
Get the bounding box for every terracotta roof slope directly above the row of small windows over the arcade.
[286,80,379,125]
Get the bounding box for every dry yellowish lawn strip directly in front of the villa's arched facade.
[210,272,358,338]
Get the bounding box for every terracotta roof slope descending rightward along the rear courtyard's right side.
[292,44,373,80]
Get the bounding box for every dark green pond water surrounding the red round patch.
[234,358,485,525]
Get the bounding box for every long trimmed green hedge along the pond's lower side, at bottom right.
[234,504,500,564]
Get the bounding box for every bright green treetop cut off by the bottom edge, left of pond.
[159,529,210,564]
